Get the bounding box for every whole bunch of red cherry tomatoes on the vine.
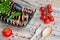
[40,4,54,24]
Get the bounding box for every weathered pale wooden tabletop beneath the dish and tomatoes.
[0,0,60,40]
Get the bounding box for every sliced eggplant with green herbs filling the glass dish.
[0,0,35,27]
